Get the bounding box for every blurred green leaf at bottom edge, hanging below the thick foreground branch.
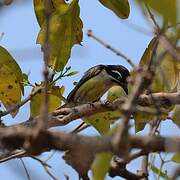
[91,152,113,180]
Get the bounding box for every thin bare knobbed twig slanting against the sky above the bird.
[87,30,135,68]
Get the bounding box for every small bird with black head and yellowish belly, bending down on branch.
[62,65,130,107]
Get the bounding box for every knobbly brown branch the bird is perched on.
[18,92,180,128]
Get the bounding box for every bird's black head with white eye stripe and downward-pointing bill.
[105,65,130,94]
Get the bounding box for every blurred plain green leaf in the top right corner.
[143,0,178,25]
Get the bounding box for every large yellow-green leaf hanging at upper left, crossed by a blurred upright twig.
[34,0,83,71]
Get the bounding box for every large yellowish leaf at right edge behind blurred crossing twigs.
[140,37,180,92]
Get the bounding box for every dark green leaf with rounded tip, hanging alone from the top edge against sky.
[99,0,130,19]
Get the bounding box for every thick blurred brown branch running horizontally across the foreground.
[0,126,180,155]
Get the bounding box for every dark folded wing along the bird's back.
[67,65,104,102]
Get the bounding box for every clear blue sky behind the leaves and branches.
[0,0,178,180]
